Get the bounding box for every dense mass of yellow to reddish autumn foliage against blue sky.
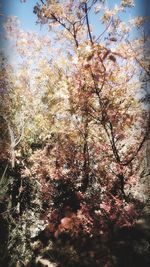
[0,0,149,267]
